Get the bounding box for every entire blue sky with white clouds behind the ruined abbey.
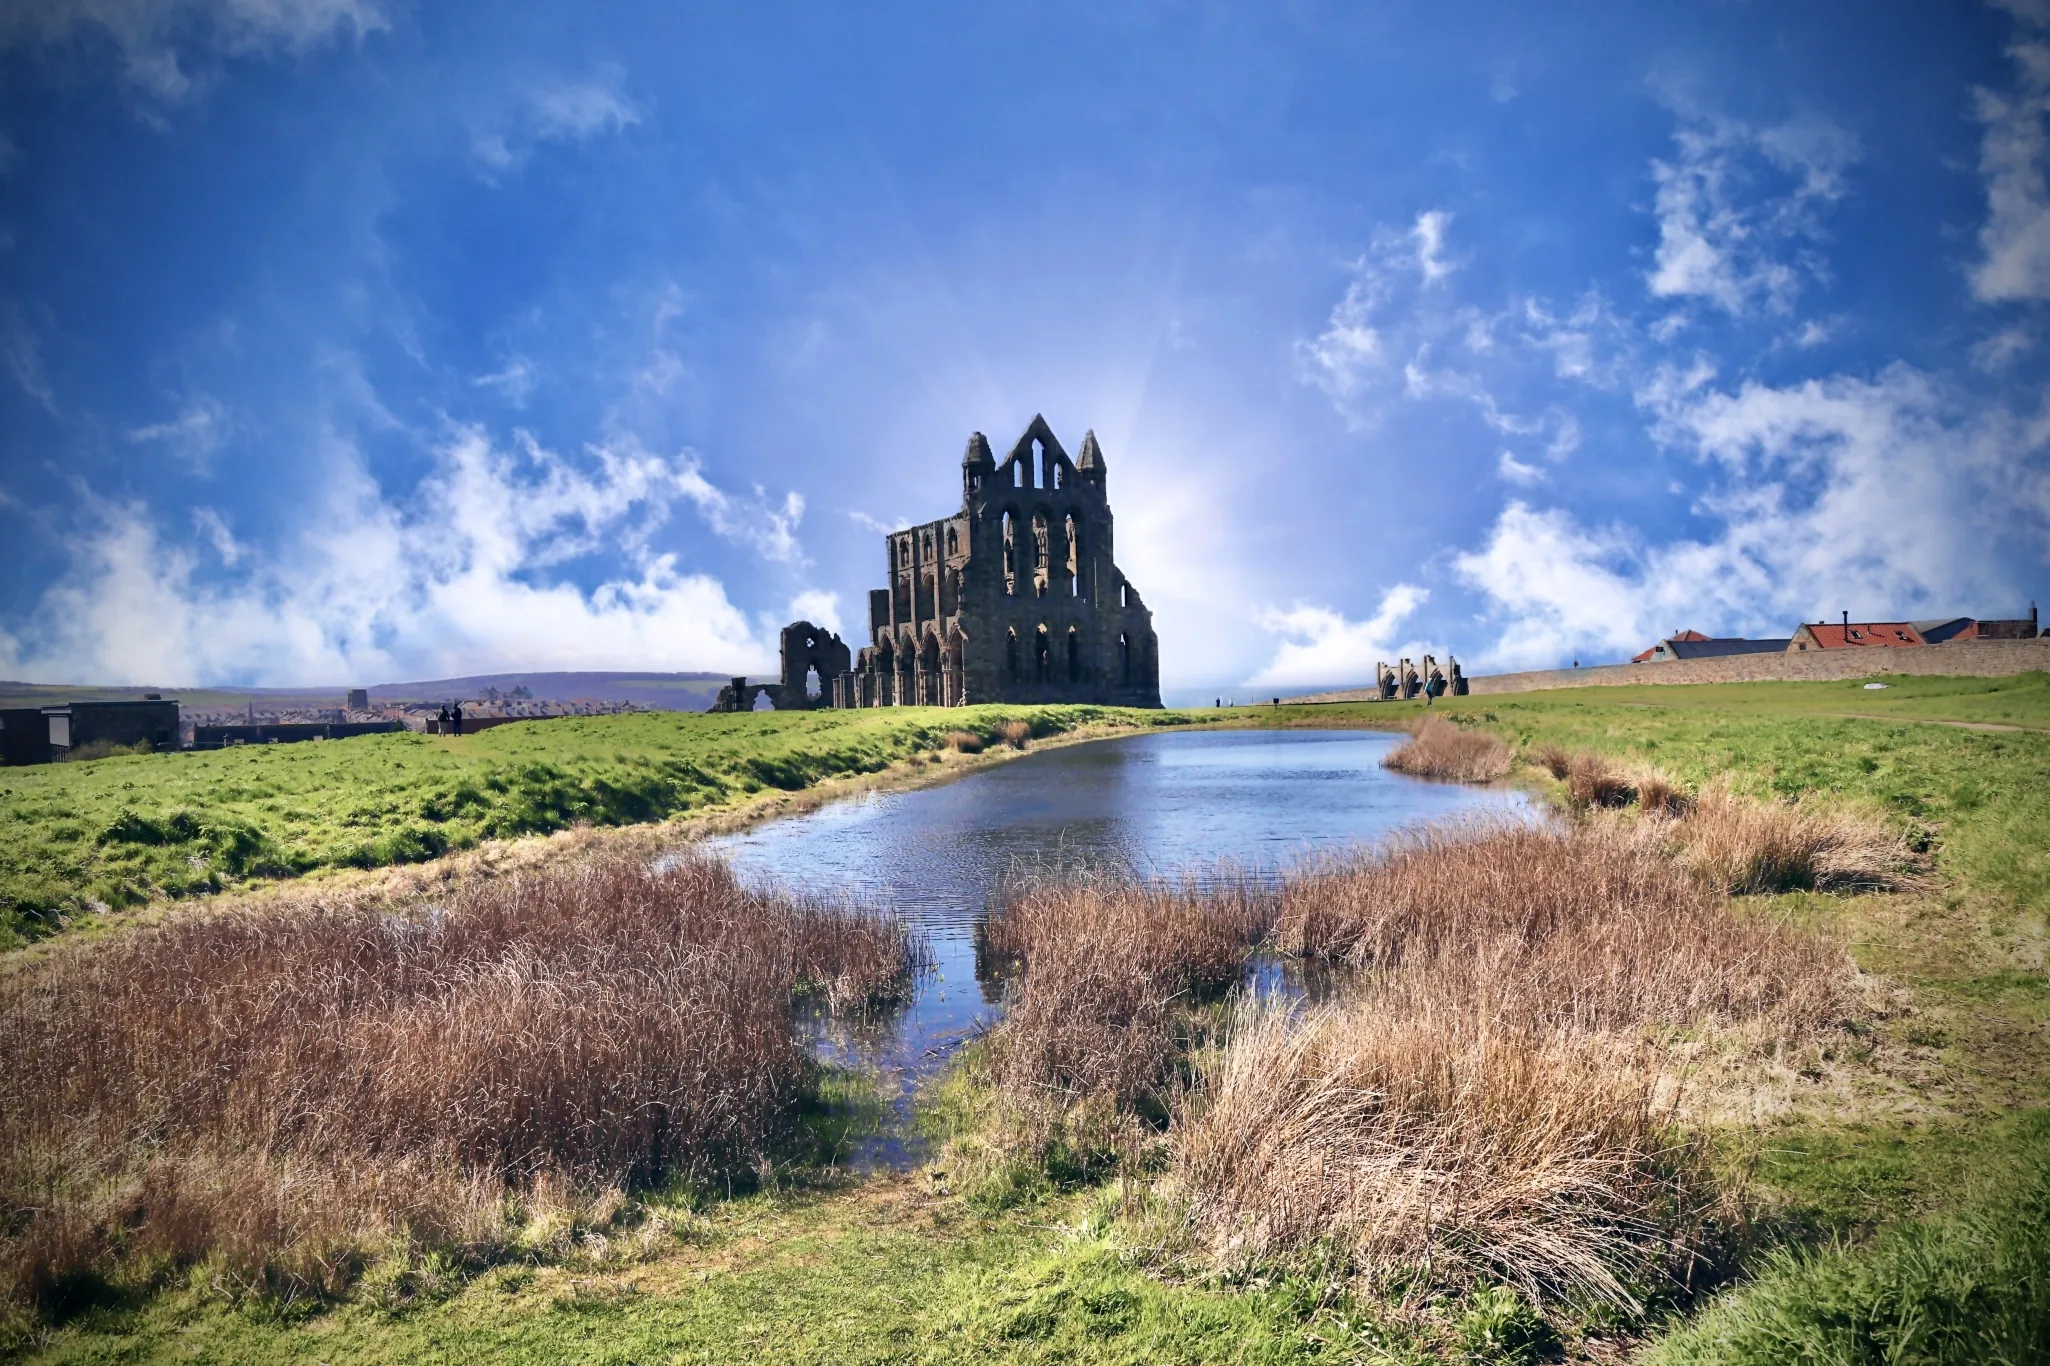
[0,0,2050,697]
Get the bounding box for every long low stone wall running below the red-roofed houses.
[1283,636,2050,701]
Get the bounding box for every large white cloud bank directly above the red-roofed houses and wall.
[1453,365,2050,667]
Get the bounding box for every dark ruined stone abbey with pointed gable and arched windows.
[713,416,1160,710]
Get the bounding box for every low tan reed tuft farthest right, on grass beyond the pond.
[1673,781,1927,894]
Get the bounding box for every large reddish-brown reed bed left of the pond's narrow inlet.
[0,859,914,1298]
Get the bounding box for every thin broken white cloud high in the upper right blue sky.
[1646,117,1857,314]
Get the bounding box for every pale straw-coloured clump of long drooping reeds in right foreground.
[1175,996,1710,1309]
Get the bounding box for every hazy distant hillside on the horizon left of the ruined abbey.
[0,673,728,712]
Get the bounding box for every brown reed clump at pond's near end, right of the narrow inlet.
[984,878,1273,1144]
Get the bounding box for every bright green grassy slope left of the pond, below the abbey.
[0,706,1183,950]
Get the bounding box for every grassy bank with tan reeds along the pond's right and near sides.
[16,679,2050,1366]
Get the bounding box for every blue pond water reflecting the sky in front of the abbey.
[705,730,1525,1161]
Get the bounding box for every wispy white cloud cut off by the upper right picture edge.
[1972,39,2050,304]
